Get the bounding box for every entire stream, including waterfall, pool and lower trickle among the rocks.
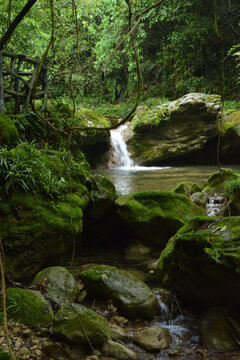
[86,125,240,360]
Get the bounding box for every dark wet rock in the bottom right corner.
[200,308,240,350]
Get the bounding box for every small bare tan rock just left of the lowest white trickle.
[133,325,170,351]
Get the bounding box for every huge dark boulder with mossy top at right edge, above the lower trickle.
[159,217,240,307]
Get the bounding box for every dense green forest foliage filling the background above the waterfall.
[0,0,240,106]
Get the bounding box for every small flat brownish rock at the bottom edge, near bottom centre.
[102,340,138,360]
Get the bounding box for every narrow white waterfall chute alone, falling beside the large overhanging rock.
[108,125,133,169]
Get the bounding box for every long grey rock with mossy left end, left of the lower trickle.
[80,265,158,318]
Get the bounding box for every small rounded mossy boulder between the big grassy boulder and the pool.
[87,175,116,219]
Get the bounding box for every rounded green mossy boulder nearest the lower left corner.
[6,288,54,327]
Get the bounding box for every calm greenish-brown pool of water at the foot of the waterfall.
[94,166,240,195]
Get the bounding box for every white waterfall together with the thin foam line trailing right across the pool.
[110,124,166,171]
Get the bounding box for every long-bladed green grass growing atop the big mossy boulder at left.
[0,142,86,197]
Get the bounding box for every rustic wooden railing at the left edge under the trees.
[0,52,48,114]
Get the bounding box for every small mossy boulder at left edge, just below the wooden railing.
[0,114,19,146]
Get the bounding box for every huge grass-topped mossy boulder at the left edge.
[0,143,90,279]
